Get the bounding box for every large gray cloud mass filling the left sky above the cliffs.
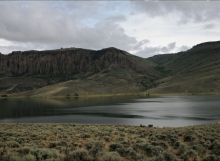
[0,1,137,53]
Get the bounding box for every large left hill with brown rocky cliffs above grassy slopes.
[0,47,160,95]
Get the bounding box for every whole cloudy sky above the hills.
[0,0,220,58]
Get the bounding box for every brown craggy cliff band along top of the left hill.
[0,48,155,75]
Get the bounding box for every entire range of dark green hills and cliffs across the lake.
[0,41,220,96]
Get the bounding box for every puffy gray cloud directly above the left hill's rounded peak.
[75,22,137,50]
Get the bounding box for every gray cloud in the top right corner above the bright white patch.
[132,1,220,24]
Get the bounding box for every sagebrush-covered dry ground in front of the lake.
[0,123,220,161]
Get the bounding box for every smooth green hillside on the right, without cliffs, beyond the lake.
[148,41,220,93]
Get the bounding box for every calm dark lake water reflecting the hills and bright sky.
[0,96,220,127]
